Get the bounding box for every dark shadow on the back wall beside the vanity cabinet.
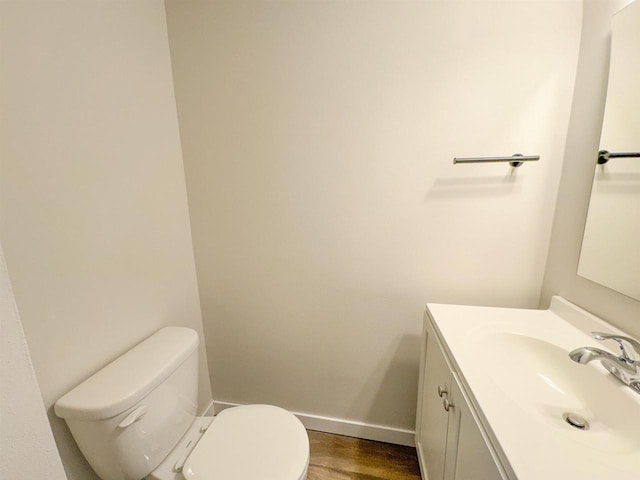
[347,335,422,429]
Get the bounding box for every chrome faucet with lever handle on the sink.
[569,332,640,393]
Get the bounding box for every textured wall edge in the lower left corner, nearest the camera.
[0,249,67,480]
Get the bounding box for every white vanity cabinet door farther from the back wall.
[444,375,506,480]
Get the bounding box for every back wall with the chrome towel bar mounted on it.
[167,0,581,436]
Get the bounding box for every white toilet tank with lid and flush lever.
[55,327,198,480]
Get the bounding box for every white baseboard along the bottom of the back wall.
[212,400,415,447]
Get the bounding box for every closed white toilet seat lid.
[182,405,309,480]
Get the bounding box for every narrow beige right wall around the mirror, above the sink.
[541,0,640,336]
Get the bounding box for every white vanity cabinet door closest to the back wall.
[418,329,451,480]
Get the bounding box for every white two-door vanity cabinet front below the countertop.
[416,314,508,480]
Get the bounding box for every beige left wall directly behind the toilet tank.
[0,1,211,479]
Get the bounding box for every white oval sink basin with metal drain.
[476,332,640,453]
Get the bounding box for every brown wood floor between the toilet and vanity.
[307,430,421,480]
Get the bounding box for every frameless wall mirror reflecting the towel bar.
[578,0,640,300]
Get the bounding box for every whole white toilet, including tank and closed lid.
[54,327,309,480]
